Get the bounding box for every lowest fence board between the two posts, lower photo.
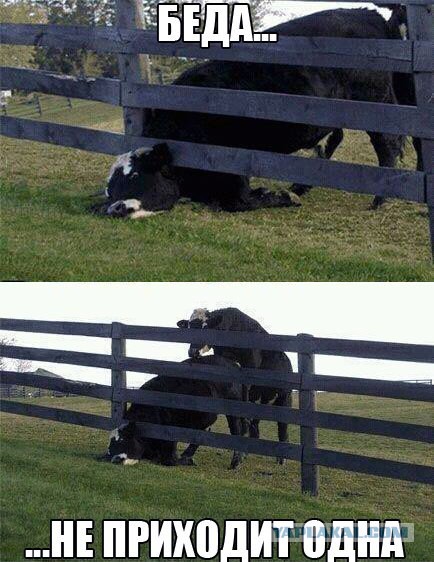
[136,422,301,461]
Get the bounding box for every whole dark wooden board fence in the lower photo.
[0,319,434,495]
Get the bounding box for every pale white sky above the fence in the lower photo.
[0,283,434,386]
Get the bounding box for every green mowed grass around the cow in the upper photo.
[0,97,434,281]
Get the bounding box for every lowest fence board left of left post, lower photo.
[0,400,113,430]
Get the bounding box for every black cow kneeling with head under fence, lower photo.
[105,356,247,469]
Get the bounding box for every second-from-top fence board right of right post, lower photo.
[303,375,434,402]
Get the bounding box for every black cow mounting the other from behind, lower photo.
[177,308,292,462]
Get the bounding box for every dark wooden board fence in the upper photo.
[0,0,434,254]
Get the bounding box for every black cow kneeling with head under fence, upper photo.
[99,9,403,218]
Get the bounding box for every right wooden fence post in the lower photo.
[297,334,319,496]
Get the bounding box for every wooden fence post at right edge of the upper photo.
[407,4,434,259]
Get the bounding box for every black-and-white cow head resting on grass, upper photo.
[102,143,179,219]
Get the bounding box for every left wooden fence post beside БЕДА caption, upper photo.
[116,0,150,137]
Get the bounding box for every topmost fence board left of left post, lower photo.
[0,318,112,338]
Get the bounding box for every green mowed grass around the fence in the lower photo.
[1,394,434,562]
